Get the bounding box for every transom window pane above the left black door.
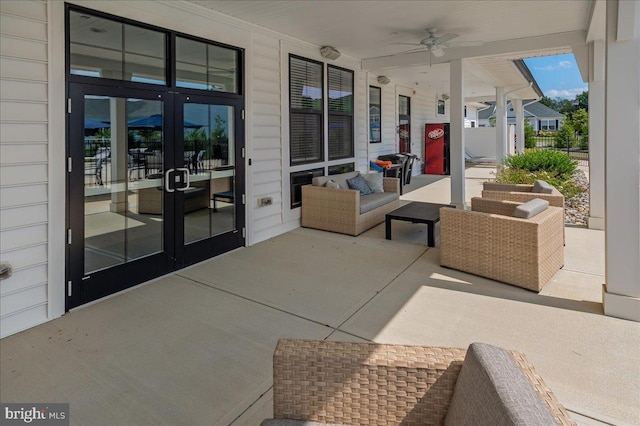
[69,10,167,85]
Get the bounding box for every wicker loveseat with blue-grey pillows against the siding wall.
[300,172,400,236]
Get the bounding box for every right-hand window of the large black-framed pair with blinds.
[327,65,353,160]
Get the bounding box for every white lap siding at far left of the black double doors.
[0,0,49,337]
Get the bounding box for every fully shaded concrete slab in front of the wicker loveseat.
[179,228,424,327]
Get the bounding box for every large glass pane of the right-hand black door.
[182,103,236,245]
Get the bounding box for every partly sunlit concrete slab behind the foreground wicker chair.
[340,249,640,423]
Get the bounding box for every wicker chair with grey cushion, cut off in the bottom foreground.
[262,339,575,426]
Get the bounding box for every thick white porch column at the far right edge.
[603,0,640,321]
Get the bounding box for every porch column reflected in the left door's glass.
[109,98,129,213]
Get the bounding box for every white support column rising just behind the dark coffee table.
[449,59,465,209]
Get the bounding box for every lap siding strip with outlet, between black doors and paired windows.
[249,34,283,243]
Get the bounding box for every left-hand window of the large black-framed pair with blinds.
[289,55,324,166]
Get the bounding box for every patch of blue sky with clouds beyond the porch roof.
[524,53,588,99]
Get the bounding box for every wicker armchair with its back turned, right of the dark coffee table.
[440,197,564,291]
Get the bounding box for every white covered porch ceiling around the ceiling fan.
[191,0,604,101]
